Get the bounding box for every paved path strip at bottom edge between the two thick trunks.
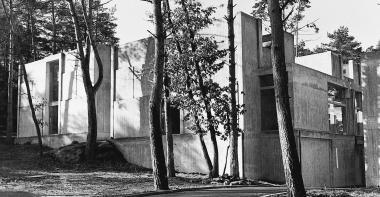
[147,187,286,197]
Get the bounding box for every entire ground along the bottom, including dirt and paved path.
[0,144,380,197]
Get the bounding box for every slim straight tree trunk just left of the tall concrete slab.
[227,0,239,178]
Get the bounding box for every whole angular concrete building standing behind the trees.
[17,13,364,187]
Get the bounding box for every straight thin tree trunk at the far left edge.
[4,0,14,144]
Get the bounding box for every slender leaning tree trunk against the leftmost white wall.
[21,62,43,156]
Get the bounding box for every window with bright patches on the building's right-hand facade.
[328,84,346,134]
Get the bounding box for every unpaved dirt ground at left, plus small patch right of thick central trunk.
[0,144,211,196]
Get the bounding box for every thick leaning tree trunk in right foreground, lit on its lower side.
[268,0,306,197]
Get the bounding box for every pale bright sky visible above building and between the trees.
[109,0,380,49]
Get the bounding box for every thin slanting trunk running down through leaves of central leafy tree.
[164,0,213,177]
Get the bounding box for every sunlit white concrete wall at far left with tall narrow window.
[18,46,111,144]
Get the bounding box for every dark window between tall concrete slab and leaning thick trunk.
[259,74,278,131]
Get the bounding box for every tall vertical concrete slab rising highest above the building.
[235,13,262,178]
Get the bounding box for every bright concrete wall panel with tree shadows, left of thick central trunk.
[112,38,154,138]
